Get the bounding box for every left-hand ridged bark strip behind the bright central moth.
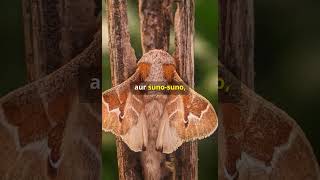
[106,0,142,180]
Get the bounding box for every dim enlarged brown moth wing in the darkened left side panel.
[0,70,101,180]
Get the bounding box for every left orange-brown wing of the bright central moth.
[102,72,148,152]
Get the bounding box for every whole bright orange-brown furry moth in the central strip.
[102,50,218,179]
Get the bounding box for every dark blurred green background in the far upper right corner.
[255,0,320,161]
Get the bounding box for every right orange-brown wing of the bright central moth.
[157,72,218,154]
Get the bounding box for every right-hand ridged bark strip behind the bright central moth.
[174,0,198,180]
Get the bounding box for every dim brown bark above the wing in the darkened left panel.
[23,0,101,81]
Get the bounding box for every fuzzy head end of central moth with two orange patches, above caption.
[138,49,176,82]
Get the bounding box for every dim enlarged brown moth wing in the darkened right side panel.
[218,64,320,180]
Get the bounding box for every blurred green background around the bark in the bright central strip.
[102,0,218,180]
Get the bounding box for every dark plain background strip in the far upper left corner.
[0,0,27,97]
